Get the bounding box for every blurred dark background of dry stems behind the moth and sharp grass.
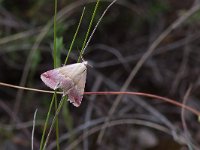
[0,0,200,150]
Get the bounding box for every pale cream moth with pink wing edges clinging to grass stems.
[40,61,88,107]
